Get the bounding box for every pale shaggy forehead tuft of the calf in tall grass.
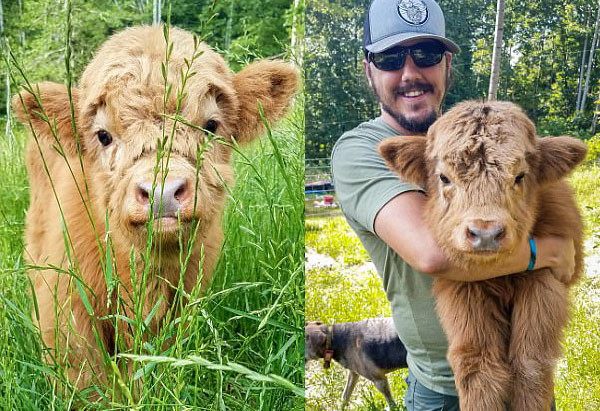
[80,26,234,117]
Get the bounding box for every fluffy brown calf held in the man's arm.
[379,102,586,411]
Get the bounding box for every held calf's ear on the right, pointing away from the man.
[537,137,587,183]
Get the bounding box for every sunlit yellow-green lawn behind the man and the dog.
[305,165,600,411]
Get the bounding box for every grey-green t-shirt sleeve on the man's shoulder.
[331,133,423,234]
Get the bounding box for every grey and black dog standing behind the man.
[304,318,408,410]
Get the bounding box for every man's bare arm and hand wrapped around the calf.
[374,191,575,281]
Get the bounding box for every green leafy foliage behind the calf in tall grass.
[0,0,302,113]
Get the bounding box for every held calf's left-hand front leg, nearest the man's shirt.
[434,279,510,411]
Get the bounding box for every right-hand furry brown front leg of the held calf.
[509,270,568,411]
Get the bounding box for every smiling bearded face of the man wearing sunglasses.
[363,40,452,133]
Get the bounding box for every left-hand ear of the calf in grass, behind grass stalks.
[11,82,79,155]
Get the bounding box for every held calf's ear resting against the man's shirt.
[377,136,427,187]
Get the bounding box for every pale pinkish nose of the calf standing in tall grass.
[136,178,190,217]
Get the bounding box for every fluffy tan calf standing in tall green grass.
[13,27,298,386]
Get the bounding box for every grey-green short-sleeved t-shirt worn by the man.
[331,117,457,395]
